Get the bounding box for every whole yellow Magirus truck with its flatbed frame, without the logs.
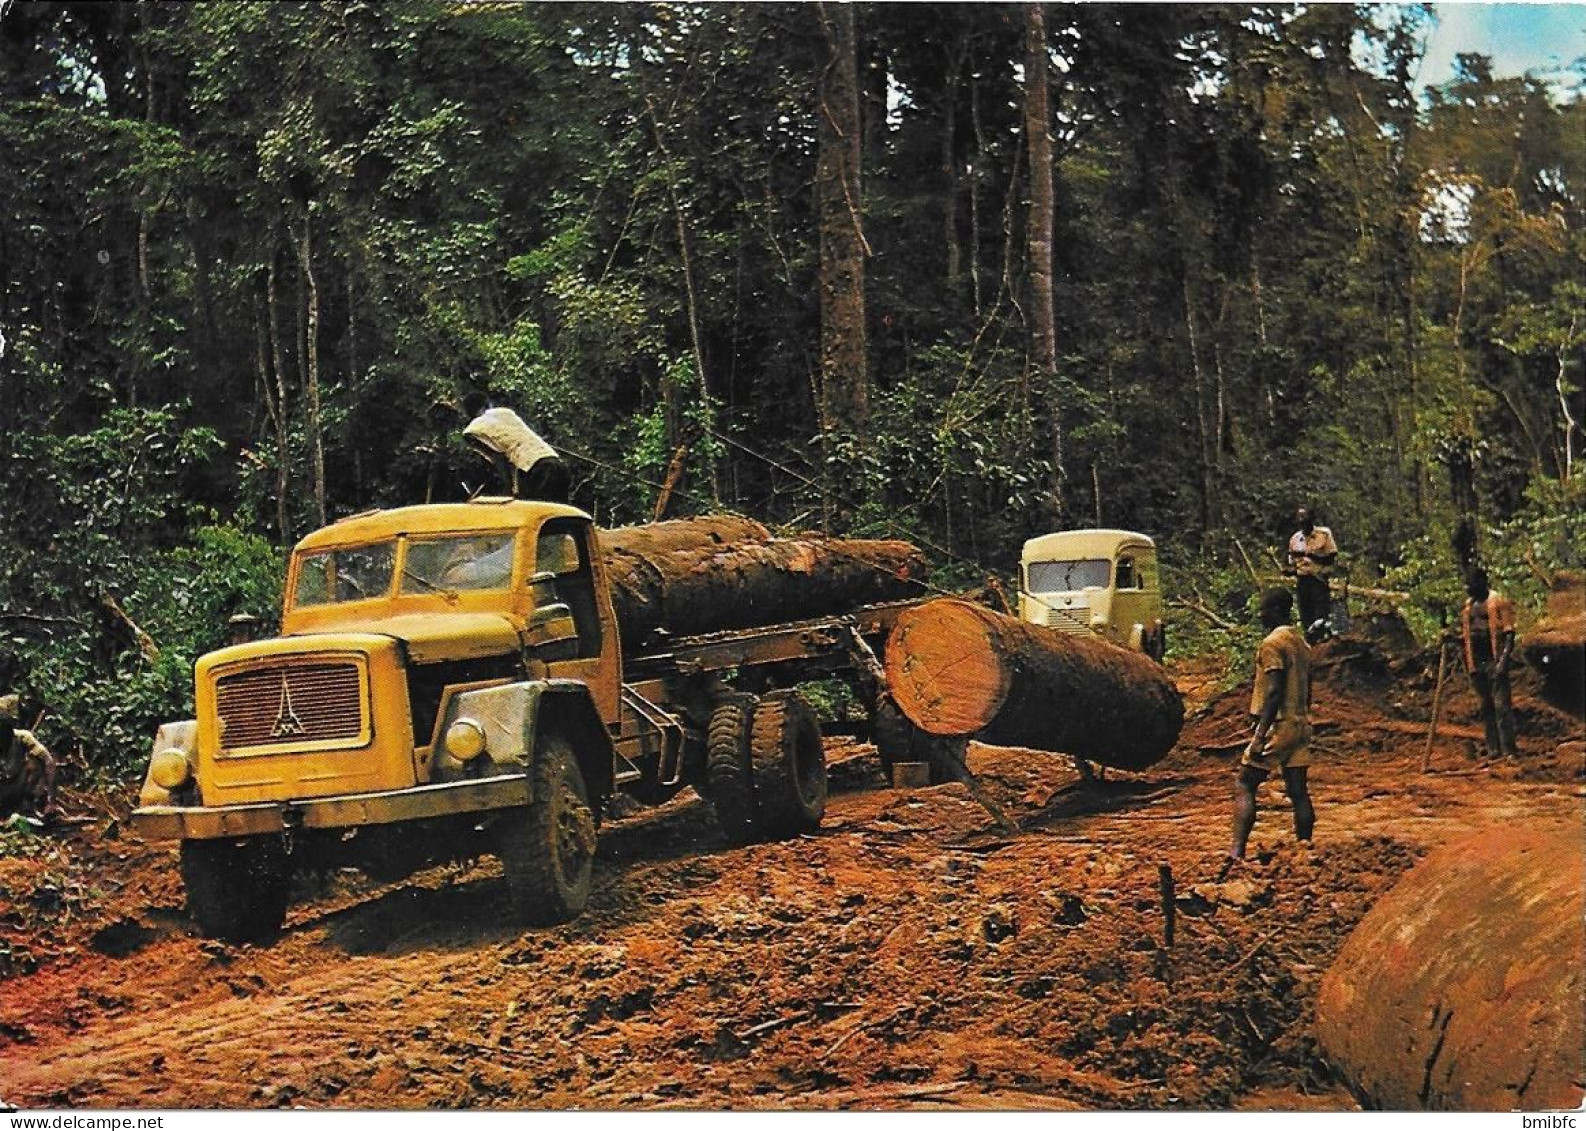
[132,498,910,941]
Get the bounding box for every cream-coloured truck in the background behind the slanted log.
[1018,530,1167,663]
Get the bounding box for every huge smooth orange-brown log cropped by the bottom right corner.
[1316,820,1586,1110]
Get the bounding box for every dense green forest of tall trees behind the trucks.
[0,0,1586,766]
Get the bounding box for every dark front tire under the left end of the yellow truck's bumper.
[182,836,292,942]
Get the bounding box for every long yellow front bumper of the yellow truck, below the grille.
[132,774,533,841]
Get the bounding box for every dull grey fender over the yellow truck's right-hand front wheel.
[435,679,615,798]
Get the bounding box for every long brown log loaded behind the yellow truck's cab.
[601,523,925,649]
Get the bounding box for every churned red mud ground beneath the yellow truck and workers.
[0,640,1583,1110]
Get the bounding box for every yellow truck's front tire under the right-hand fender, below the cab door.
[493,733,595,926]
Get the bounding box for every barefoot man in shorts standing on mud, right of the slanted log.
[1223,589,1316,872]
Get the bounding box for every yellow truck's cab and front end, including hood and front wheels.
[133,498,631,939]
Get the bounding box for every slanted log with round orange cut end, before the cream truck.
[885,598,1183,769]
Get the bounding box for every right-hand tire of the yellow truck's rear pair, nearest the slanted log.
[749,692,826,839]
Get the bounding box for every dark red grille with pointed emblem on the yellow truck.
[214,663,365,750]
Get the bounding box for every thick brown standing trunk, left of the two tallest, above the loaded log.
[815,3,869,431]
